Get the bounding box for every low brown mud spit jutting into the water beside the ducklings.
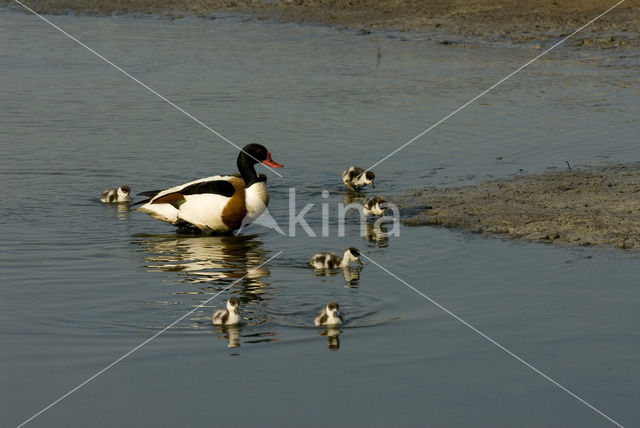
[394,162,640,250]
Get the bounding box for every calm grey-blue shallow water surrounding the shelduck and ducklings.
[0,12,640,426]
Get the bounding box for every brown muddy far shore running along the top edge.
[7,0,640,48]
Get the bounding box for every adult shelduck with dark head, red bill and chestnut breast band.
[135,144,283,233]
